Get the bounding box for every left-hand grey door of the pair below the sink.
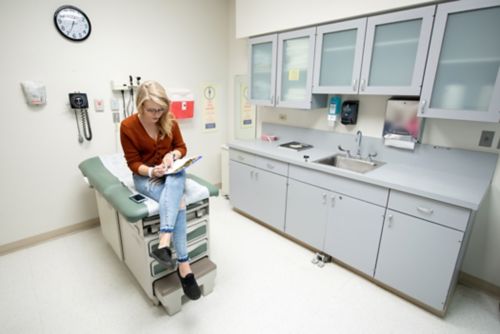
[285,179,330,249]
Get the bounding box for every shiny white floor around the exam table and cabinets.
[0,197,500,334]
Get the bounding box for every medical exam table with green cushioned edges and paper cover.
[78,154,219,315]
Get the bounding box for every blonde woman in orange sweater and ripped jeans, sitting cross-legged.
[120,81,201,300]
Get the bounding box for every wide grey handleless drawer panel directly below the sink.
[289,166,389,207]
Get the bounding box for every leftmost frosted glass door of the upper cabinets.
[248,34,277,106]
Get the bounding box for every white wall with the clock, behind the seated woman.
[0,0,228,245]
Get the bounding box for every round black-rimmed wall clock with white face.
[54,6,92,41]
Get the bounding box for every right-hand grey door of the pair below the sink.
[324,193,385,277]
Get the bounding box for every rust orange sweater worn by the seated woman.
[120,114,187,174]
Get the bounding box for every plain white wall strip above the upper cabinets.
[236,0,435,38]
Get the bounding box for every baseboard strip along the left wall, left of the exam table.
[0,218,99,255]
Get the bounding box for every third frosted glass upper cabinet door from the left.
[313,19,366,94]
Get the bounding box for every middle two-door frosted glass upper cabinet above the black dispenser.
[313,6,435,95]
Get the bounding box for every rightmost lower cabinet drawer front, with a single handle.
[388,190,470,231]
